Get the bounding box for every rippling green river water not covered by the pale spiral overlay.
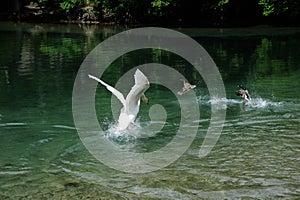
[0,23,300,199]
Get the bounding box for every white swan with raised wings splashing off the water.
[89,69,150,130]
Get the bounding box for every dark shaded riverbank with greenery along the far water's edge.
[0,0,300,28]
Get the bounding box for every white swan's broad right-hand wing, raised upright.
[125,69,149,115]
